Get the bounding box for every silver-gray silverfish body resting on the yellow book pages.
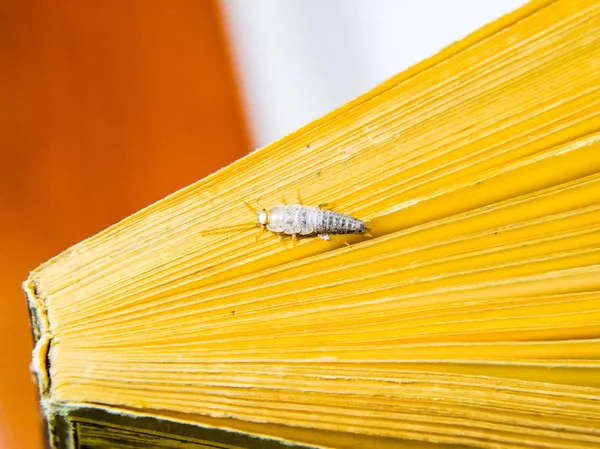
[258,204,367,240]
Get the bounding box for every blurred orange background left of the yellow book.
[0,0,250,449]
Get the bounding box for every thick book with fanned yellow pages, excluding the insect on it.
[24,0,600,449]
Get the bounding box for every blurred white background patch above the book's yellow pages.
[221,0,525,148]
